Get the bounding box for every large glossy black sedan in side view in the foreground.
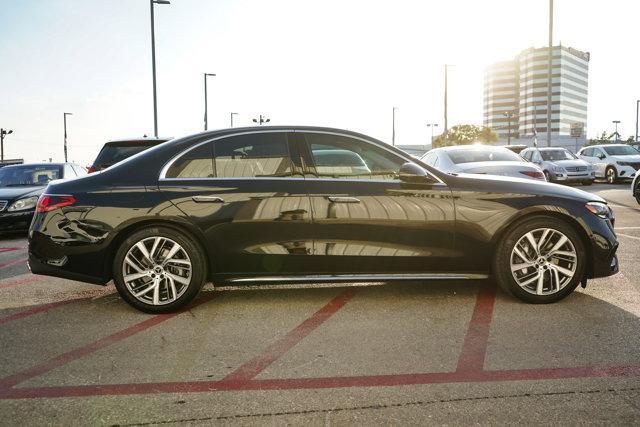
[29,127,618,313]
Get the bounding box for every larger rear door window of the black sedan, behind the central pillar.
[213,132,293,178]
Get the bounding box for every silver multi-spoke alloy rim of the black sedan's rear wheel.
[122,236,192,305]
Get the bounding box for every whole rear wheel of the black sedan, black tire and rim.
[113,227,207,314]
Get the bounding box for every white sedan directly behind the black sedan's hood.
[422,145,545,181]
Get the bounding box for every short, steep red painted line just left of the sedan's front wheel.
[456,284,496,372]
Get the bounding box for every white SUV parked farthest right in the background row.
[578,144,640,184]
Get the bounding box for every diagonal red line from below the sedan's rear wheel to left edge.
[0,298,218,390]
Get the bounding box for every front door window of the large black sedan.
[305,133,406,180]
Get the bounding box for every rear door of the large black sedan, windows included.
[160,131,312,277]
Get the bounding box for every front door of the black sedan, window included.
[302,132,456,275]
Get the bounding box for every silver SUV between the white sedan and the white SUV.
[520,147,595,185]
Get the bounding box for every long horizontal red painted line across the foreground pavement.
[0,366,640,400]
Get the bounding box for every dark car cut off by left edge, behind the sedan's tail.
[0,163,87,232]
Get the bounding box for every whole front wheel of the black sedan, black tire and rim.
[493,216,587,304]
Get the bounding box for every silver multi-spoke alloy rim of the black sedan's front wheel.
[510,228,578,295]
